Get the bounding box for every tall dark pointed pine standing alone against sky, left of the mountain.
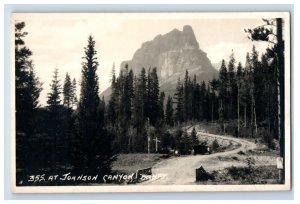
[75,36,113,173]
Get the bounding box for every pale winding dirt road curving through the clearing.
[142,126,256,185]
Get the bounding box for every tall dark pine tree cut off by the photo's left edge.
[15,22,42,170]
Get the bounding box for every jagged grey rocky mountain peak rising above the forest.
[102,25,217,99]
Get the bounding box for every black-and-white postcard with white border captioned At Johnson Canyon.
[10,12,291,192]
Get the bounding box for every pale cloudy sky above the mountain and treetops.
[12,13,268,105]
